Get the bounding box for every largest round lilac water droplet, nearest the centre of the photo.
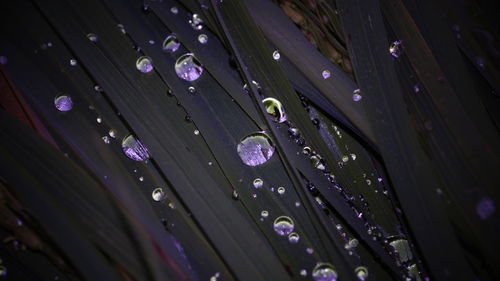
[236,132,275,166]
